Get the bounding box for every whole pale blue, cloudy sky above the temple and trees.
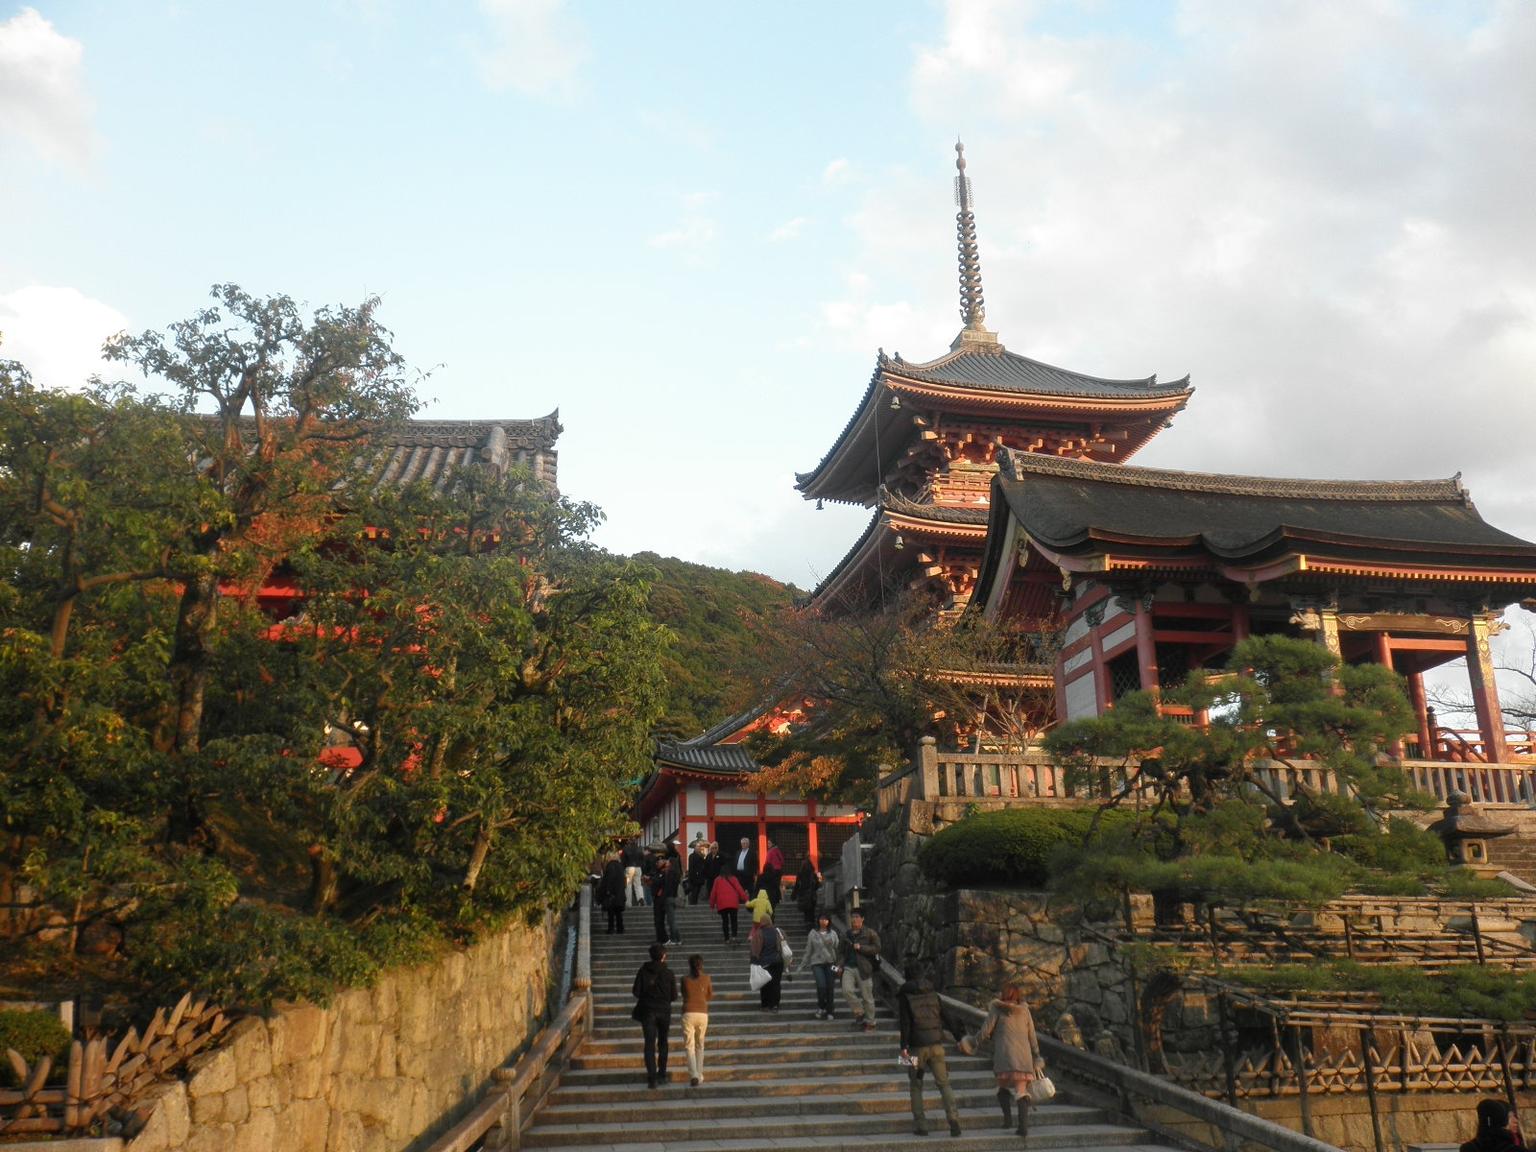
[0,0,1536,694]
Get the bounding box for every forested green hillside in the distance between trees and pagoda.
[634,551,802,739]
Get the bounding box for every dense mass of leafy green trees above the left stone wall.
[0,286,665,1003]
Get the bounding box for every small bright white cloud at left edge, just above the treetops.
[0,284,127,389]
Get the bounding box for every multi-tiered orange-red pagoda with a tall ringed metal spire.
[796,143,1192,616]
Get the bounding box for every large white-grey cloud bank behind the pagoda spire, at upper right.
[822,0,1536,538]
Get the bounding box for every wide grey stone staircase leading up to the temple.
[522,903,1157,1152]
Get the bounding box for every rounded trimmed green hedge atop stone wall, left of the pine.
[917,808,1135,888]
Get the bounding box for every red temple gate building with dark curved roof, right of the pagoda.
[975,452,1536,777]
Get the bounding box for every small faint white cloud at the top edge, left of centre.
[479,0,587,97]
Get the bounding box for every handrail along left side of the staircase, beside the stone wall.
[427,885,591,1152]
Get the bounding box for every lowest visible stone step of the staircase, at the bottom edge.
[522,1112,1147,1152]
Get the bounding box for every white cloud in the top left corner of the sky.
[0,8,95,166]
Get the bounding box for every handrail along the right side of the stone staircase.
[880,957,1338,1152]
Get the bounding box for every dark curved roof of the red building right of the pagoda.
[982,452,1536,595]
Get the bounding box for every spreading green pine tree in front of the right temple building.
[1046,636,1424,905]
